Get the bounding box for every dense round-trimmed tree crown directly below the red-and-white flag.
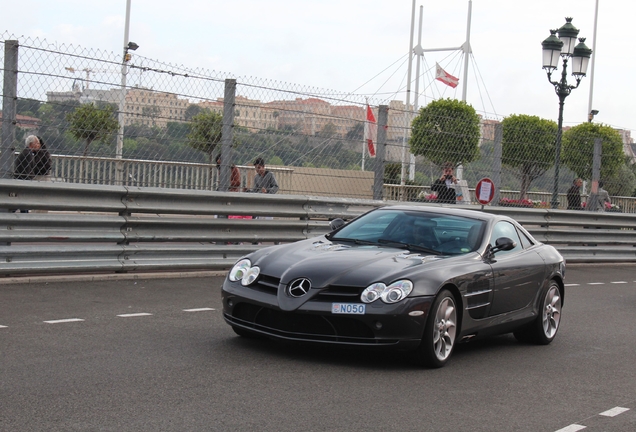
[409,98,480,166]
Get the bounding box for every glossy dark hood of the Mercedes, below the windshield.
[250,237,449,288]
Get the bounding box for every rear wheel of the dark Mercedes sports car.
[513,280,563,345]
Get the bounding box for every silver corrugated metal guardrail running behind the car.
[0,180,636,275]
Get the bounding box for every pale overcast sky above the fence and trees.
[0,0,636,133]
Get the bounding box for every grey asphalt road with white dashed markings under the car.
[0,266,636,432]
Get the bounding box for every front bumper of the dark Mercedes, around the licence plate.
[222,280,434,349]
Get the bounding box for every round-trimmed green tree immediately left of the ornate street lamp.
[501,114,558,199]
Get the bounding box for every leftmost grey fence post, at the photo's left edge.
[0,40,19,178]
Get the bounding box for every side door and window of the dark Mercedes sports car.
[489,221,545,316]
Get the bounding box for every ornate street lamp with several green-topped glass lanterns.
[541,18,592,209]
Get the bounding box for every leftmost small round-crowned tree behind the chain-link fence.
[66,104,119,156]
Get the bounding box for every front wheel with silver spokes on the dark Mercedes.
[415,289,458,368]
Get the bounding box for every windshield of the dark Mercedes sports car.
[330,209,485,255]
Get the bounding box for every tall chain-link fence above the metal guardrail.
[0,33,636,211]
